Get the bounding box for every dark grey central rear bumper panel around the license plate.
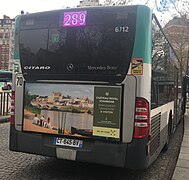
[10,124,127,167]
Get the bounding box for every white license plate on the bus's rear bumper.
[53,137,83,148]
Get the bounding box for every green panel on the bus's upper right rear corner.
[132,5,152,64]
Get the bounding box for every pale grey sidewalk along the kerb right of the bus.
[172,111,189,180]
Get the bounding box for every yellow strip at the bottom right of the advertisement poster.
[93,126,120,138]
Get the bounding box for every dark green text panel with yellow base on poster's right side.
[93,87,121,138]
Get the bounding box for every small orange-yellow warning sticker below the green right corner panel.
[131,58,143,75]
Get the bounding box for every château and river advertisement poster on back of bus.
[23,83,121,139]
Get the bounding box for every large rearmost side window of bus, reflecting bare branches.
[151,17,178,109]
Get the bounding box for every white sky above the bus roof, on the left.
[0,0,80,19]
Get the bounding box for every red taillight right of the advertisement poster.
[134,97,150,139]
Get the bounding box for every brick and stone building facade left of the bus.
[0,15,15,70]
